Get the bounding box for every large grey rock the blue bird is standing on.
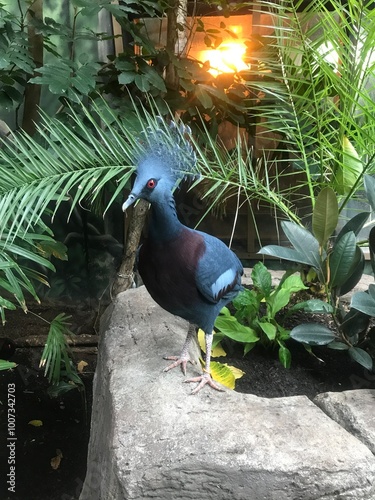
[80,287,375,500]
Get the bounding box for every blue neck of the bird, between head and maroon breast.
[149,193,183,241]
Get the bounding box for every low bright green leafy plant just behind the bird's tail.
[215,262,307,368]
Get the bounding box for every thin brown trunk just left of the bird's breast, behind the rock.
[112,200,149,296]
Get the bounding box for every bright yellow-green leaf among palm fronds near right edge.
[336,136,363,195]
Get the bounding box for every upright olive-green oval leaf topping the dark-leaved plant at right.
[312,187,339,248]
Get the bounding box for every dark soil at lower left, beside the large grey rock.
[0,308,97,500]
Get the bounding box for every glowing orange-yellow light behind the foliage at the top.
[198,42,248,76]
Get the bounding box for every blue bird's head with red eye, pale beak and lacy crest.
[122,117,197,212]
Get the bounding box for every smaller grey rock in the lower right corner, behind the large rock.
[314,389,375,454]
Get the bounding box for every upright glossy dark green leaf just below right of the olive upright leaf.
[329,231,358,287]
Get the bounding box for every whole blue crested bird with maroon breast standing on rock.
[122,118,243,394]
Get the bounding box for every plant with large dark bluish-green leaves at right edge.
[260,185,373,369]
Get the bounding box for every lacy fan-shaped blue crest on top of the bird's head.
[137,116,198,184]
